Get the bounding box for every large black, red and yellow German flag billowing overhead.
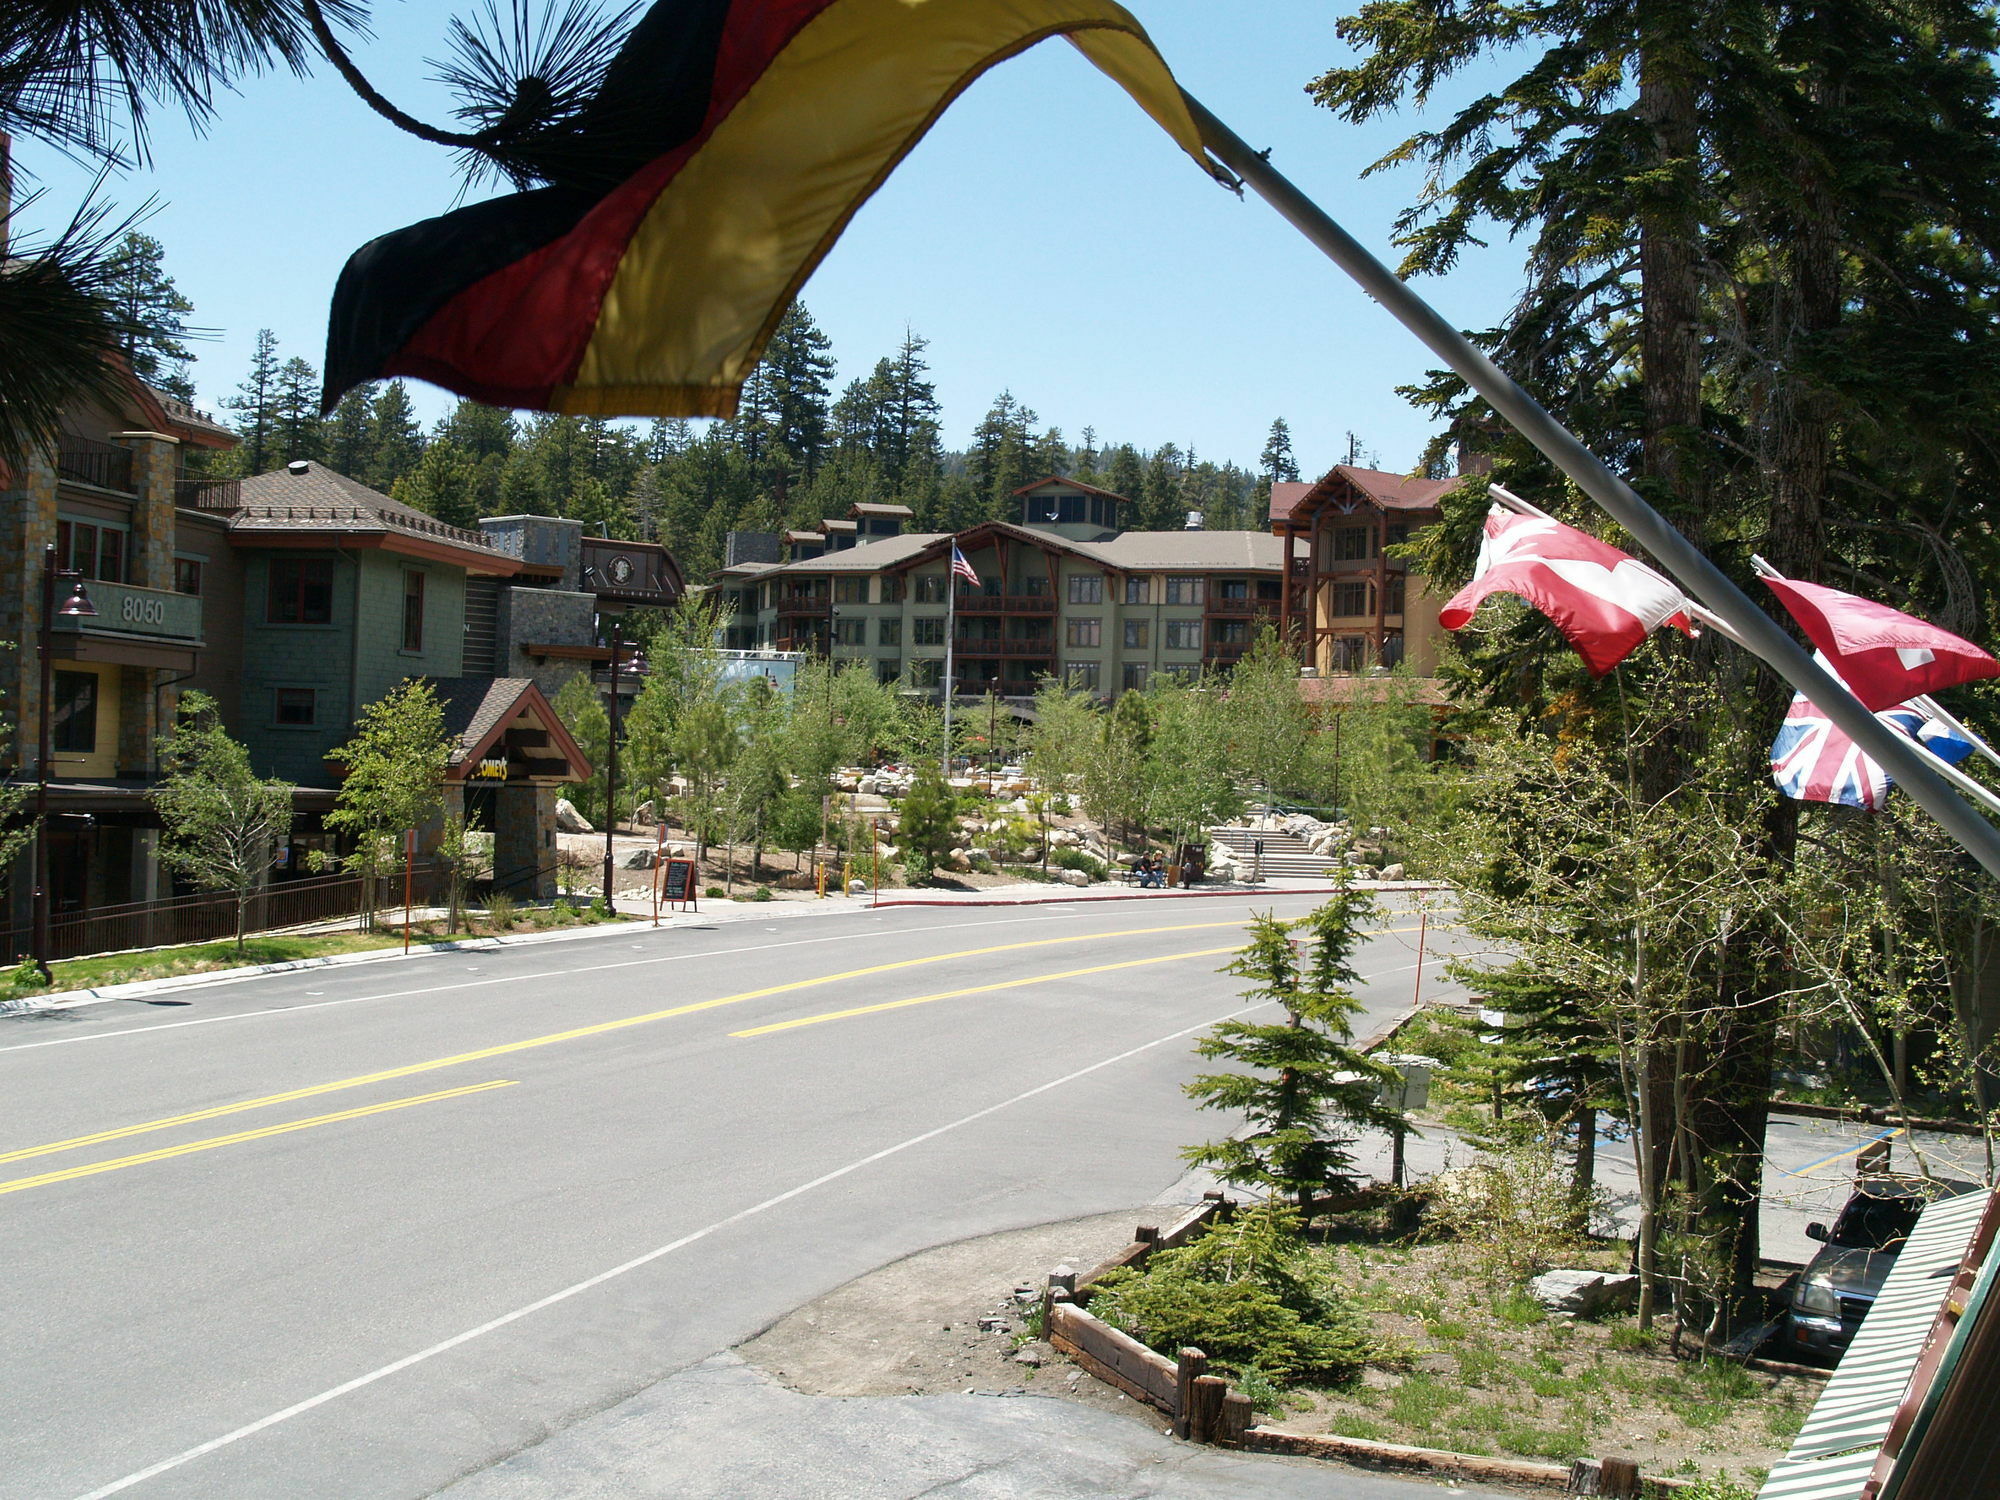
[326,0,1214,416]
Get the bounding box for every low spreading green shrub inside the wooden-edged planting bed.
[1092,1204,1386,1386]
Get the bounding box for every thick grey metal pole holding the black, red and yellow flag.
[1182,92,2000,878]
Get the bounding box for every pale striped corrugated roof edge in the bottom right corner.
[1758,1192,1992,1500]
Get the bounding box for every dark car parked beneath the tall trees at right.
[1780,1178,1976,1362]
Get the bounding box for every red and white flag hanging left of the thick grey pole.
[1438,506,1694,676]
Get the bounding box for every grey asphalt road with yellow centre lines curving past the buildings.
[0,894,1480,1500]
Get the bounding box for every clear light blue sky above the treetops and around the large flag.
[18,0,1520,470]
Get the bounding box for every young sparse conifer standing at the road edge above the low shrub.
[1182,888,1400,1218]
